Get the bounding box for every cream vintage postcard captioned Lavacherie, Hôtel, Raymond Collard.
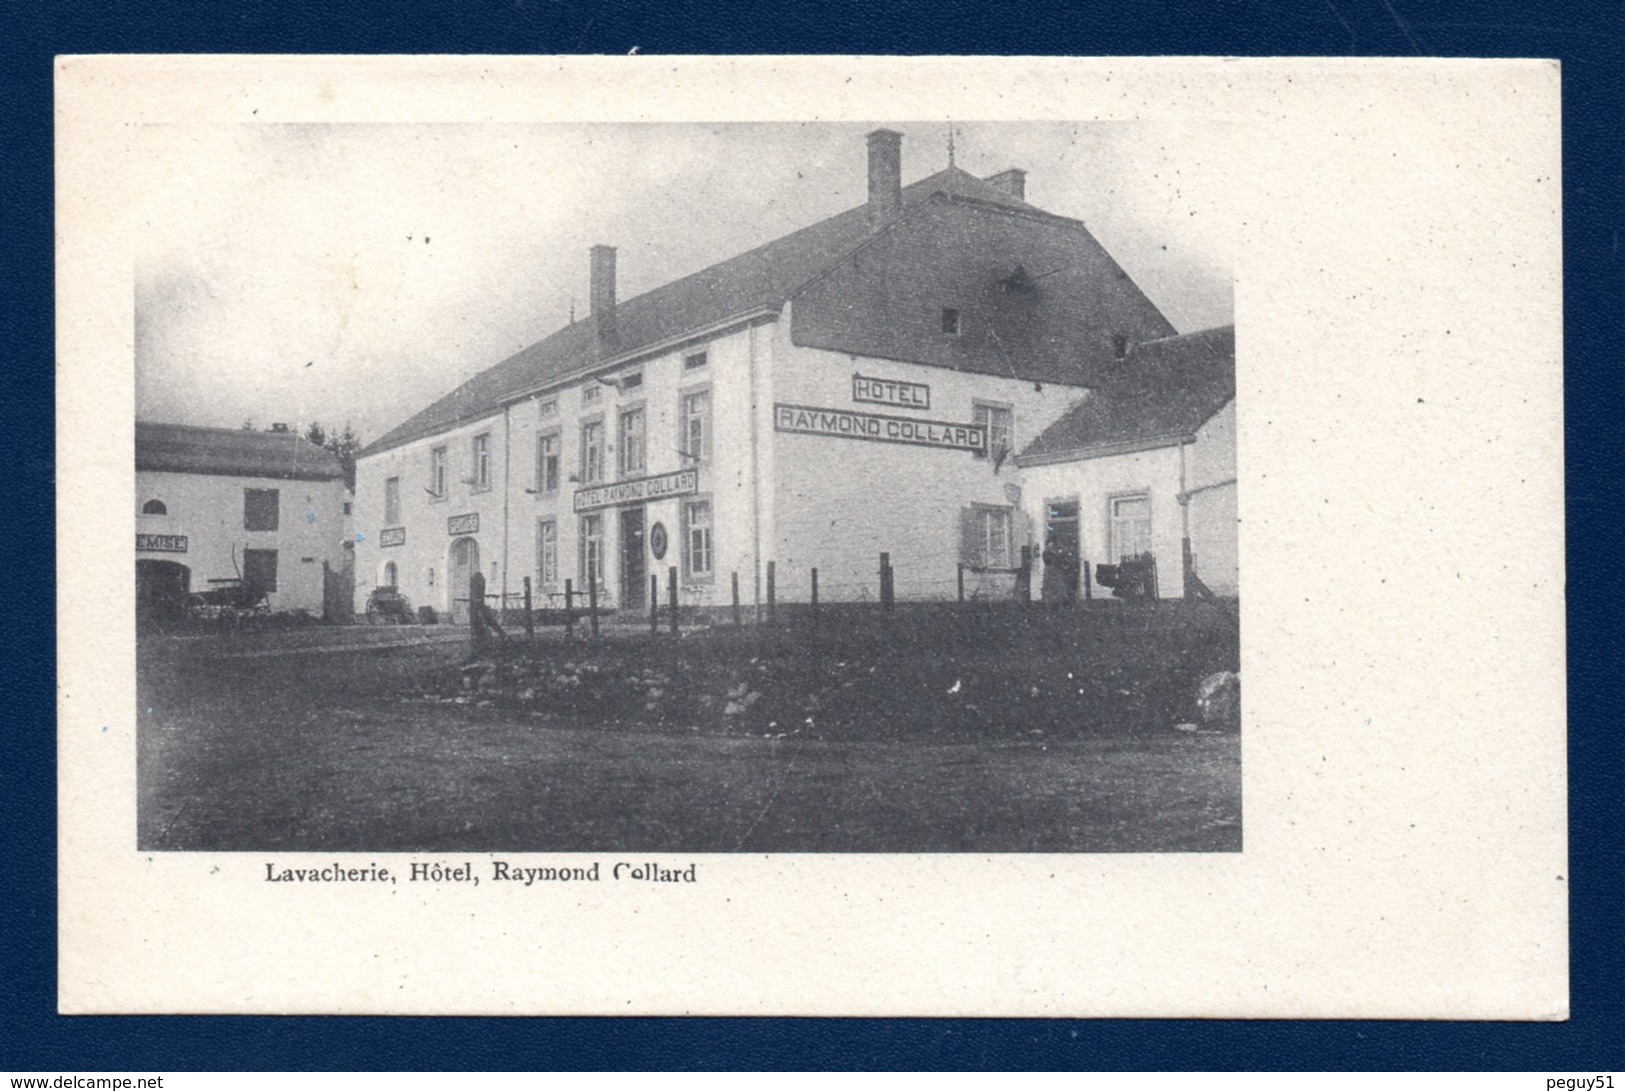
[57,57,1568,1019]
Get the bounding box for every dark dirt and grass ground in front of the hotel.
[140,614,1242,852]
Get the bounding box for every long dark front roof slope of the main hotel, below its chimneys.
[361,167,1033,457]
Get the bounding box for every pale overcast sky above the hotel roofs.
[132,122,1245,441]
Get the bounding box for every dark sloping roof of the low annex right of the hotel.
[1016,325,1235,465]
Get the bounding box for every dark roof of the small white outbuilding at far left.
[135,421,345,481]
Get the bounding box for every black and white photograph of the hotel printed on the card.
[133,119,1243,851]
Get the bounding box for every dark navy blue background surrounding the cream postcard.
[0,0,1625,1075]
